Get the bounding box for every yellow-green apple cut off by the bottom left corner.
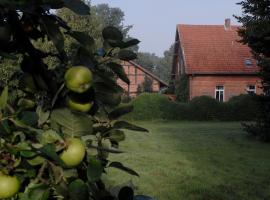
[0,172,20,199]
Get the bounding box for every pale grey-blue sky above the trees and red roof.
[92,0,241,56]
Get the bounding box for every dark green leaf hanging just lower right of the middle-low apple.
[87,157,103,183]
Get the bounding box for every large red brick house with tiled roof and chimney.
[172,19,262,102]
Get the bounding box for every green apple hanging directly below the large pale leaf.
[60,138,85,167]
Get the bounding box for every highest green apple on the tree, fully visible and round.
[65,66,93,93]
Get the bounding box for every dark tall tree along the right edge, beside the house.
[236,0,270,141]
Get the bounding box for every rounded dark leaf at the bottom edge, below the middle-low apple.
[68,179,89,200]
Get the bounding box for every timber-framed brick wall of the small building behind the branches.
[117,62,160,96]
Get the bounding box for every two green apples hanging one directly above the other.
[65,66,93,113]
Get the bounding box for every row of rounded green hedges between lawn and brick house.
[125,93,259,121]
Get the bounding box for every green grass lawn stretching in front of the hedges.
[104,122,270,200]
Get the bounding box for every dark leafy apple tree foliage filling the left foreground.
[0,0,147,200]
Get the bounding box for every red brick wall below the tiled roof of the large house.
[189,76,262,101]
